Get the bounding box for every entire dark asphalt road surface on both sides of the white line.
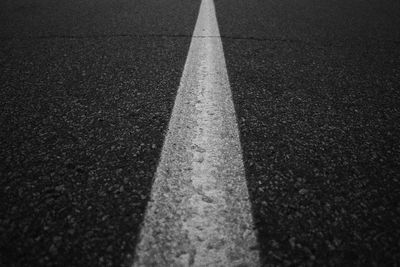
[0,0,400,266]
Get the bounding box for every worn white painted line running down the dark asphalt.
[133,0,259,266]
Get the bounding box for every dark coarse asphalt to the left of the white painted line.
[0,0,199,266]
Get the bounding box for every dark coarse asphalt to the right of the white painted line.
[216,0,400,266]
